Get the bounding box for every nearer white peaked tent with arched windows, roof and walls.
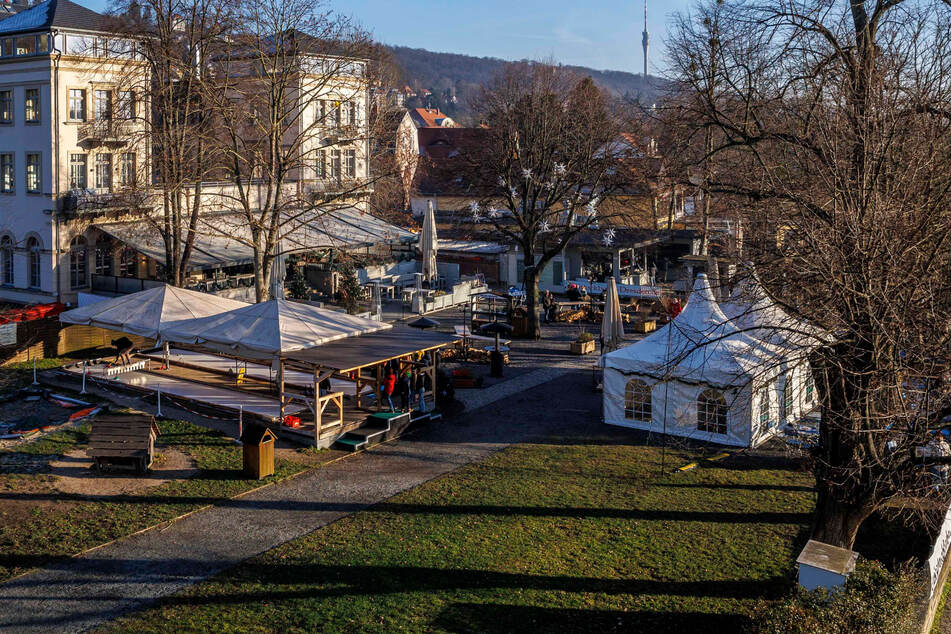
[604,275,784,447]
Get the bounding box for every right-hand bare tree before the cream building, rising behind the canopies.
[203,0,386,301]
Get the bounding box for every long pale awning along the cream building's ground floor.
[96,207,416,270]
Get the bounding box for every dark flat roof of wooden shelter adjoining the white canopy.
[286,327,456,372]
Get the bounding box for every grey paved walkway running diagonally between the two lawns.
[0,366,600,632]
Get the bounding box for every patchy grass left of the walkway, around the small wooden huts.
[0,420,313,580]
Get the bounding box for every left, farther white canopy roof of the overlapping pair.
[59,284,248,339]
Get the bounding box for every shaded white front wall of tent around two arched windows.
[603,368,752,447]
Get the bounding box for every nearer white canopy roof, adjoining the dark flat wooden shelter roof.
[165,299,392,359]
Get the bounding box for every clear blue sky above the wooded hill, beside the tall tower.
[338,0,694,74]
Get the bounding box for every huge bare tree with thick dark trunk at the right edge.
[667,0,951,548]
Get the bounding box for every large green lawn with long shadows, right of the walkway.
[102,441,813,632]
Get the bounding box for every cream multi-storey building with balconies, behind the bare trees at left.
[0,0,378,304]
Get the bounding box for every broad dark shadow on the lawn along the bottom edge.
[430,603,750,633]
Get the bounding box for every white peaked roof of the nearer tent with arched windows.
[604,275,781,388]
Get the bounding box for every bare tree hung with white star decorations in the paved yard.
[464,63,630,338]
